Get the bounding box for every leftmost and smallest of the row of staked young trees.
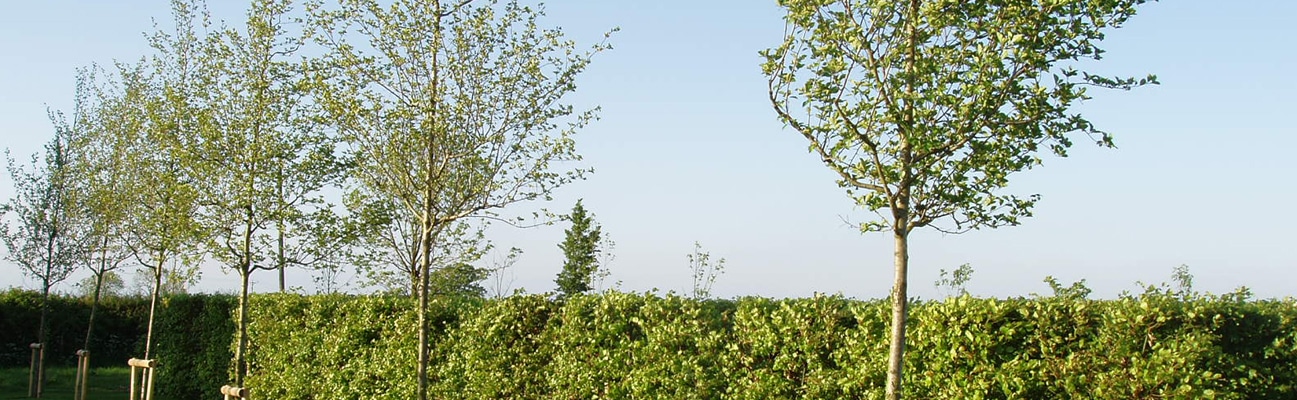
[0,112,84,397]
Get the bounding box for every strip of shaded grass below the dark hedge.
[0,366,131,400]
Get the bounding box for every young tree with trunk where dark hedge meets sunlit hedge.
[182,0,341,387]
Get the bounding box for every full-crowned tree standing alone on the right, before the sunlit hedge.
[763,0,1156,399]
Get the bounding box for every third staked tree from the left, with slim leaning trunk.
[122,0,209,358]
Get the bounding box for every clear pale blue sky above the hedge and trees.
[0,0,1297,299]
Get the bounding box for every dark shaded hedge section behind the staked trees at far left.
[0,290,236,399]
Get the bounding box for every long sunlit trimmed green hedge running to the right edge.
[241,292,1297,399]
